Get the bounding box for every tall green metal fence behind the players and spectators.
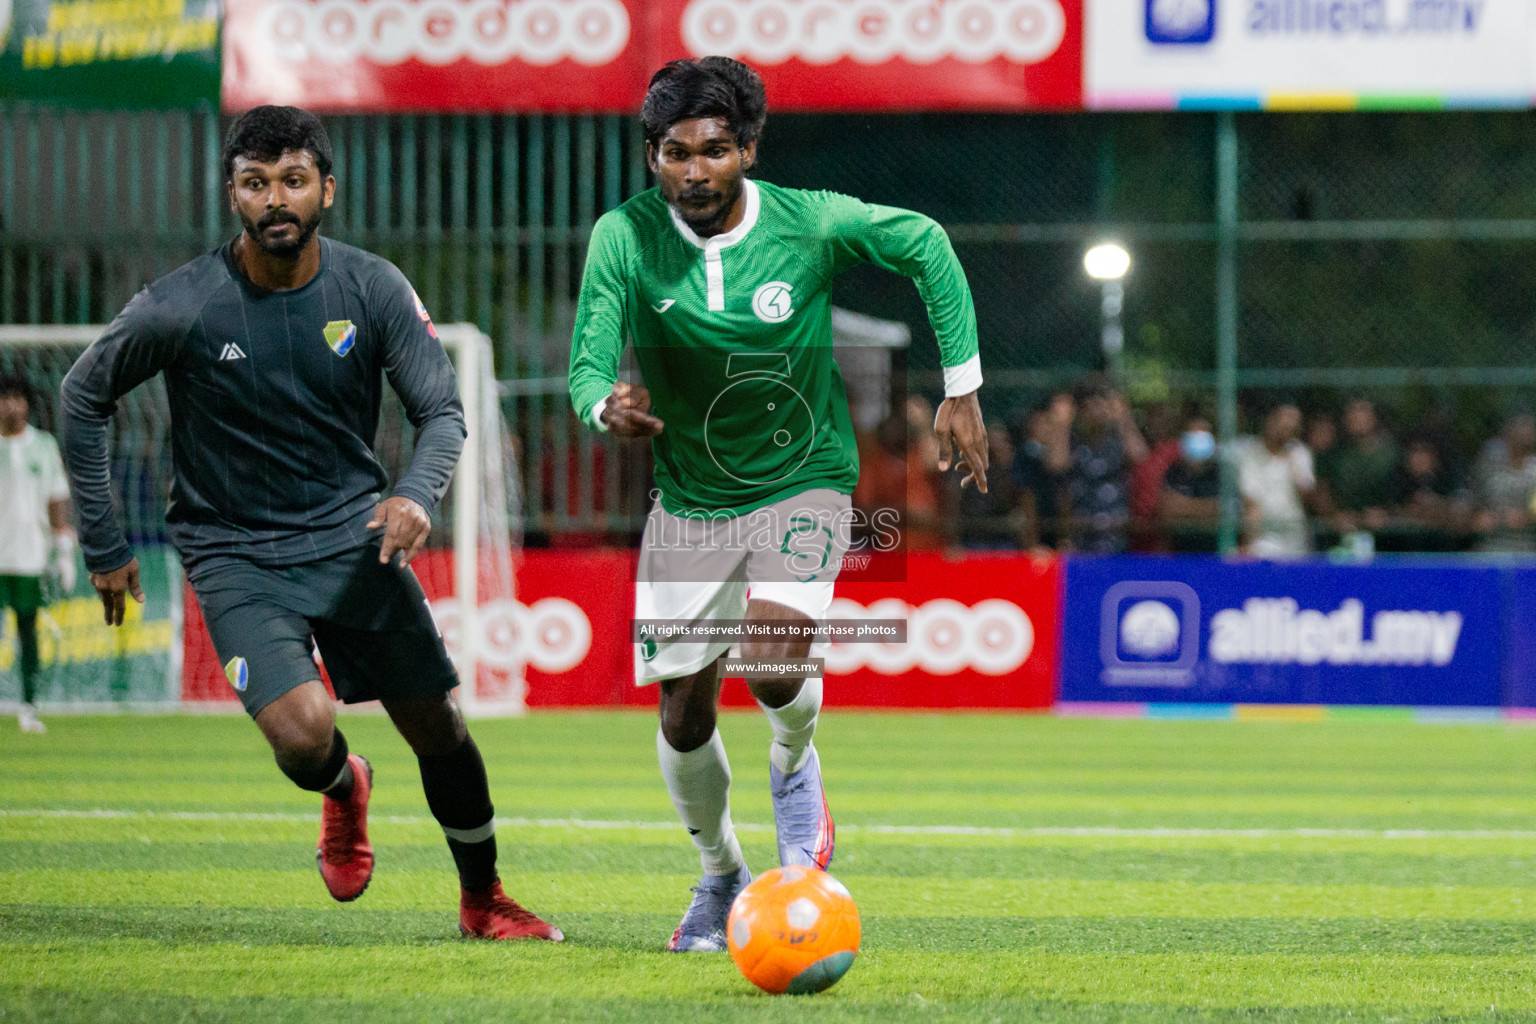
[9,106,1536,536]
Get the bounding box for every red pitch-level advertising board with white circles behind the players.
[183,550,1061,708]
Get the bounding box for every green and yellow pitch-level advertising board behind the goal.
[0,548,181,703]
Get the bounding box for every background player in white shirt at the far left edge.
[0,376,75,732]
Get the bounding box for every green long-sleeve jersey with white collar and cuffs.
[570,180,982,516]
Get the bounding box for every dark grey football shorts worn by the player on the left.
[187,539,459,717]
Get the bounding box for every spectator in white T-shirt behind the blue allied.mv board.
[1236,402,1316,559]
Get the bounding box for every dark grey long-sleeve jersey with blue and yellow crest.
[63,238,464,573]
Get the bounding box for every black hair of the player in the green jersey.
[641,57,768,146]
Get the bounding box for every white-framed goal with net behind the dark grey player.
[0,324,527,714]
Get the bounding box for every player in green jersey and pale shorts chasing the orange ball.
[570,57,988,952]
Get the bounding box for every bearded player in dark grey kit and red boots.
[63,106,562,941]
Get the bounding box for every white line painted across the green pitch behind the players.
[0,808,1536,840]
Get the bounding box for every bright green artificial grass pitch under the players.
[0,709,1536,1024]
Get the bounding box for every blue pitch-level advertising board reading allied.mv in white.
[1061,557,1504,706]
